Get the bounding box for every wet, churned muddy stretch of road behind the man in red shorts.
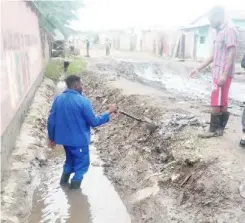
[97,58,245,115]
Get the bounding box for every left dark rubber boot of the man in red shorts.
[198,113,222,138]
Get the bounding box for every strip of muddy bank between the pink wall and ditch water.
[1,79,55,222]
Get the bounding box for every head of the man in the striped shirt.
[209,6,225,29]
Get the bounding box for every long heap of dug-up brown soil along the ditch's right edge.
[82,66,245,223]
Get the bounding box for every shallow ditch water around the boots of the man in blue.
[29,143,131,223]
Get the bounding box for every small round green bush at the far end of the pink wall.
[45,60,64,81]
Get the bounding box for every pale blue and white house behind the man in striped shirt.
[178,11,245,60]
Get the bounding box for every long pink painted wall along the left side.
[1,1,49,170]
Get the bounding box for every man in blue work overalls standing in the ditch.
[48,75,117,189]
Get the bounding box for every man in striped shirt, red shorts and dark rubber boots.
[190,6,237,138]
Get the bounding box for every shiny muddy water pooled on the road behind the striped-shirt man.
[117,59,245,115]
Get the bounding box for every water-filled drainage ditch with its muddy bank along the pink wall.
[1,79,131,223]
